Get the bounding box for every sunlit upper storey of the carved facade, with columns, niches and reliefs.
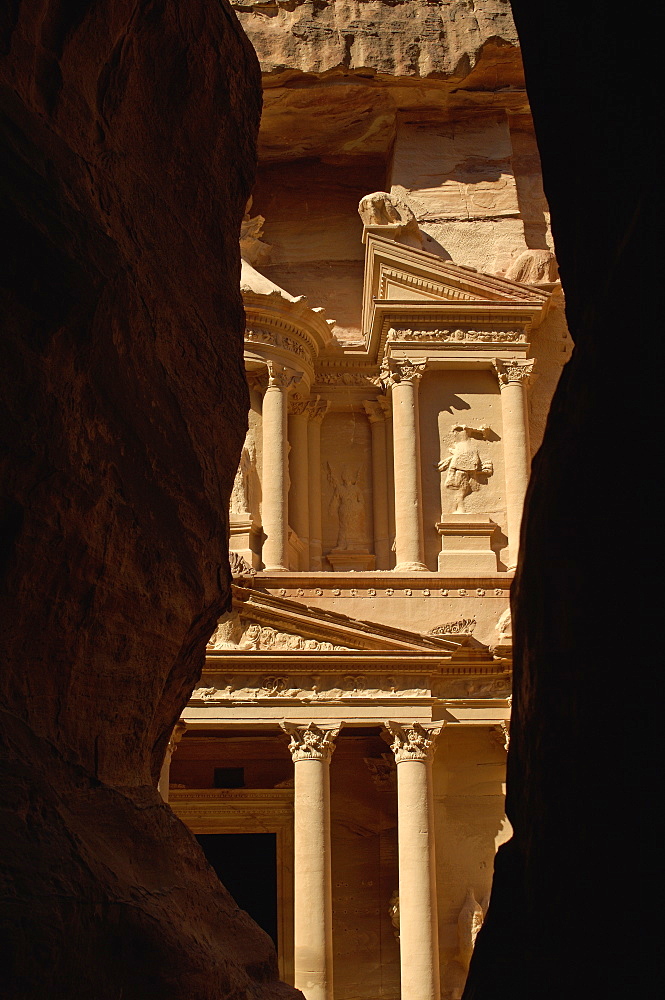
[231,193,554,575]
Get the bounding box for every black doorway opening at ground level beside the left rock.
[196,833,277,947]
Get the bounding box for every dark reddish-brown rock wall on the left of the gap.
[0,0,293,1000]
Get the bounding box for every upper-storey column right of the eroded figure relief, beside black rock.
[494,359,534,570]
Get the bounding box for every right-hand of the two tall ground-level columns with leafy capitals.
[386,722,443,1000]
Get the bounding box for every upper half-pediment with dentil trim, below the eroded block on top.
[362,233,549,358]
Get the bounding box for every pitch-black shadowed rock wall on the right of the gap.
[464,0,644,1000]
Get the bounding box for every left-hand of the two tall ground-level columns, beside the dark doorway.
[281,722,340,1000]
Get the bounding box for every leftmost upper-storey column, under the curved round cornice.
[261,361,302,572]
